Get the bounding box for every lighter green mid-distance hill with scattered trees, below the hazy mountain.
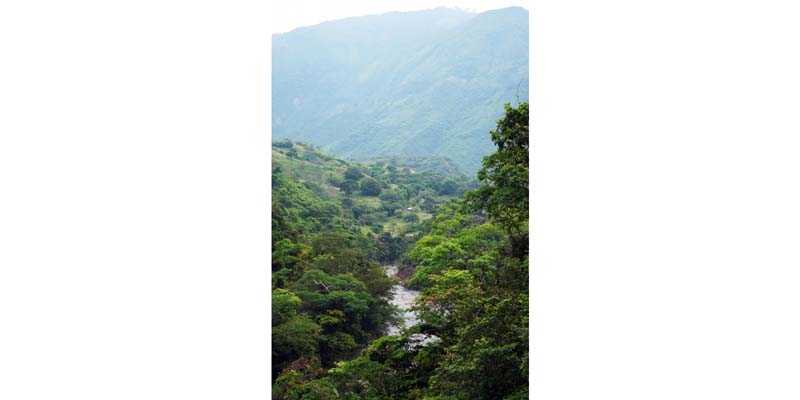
[272,141,477,237]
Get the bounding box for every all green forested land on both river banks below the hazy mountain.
[272,102,528,400]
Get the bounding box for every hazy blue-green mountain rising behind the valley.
[272,7,528,174]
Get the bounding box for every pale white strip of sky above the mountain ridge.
[271,0,530,33]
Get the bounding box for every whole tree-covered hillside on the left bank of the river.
[272,141,475,377]
